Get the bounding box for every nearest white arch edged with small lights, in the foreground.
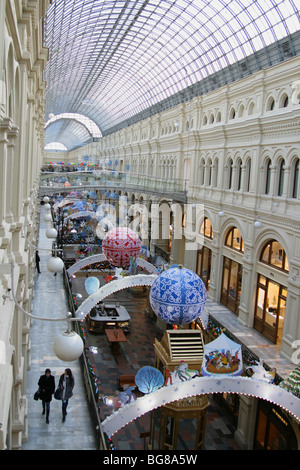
[101,376,300,436]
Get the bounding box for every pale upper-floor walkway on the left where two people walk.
[21,207,97,450]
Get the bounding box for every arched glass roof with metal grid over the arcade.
[44,0,300,148]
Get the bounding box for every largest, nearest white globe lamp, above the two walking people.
[53,331,83,362]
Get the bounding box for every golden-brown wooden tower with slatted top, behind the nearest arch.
[149,329,209,450]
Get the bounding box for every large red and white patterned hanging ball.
[102,227,142,267]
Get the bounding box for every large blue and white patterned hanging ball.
[150,266,207,325]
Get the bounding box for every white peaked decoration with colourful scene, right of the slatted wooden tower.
[201,333,243,376]
